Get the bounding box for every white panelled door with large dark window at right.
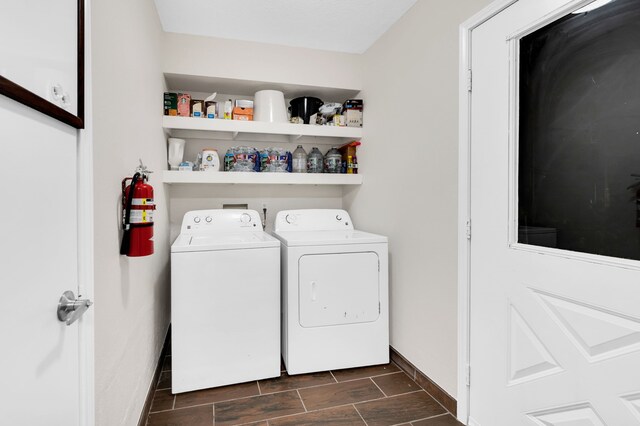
[469,0,640,426]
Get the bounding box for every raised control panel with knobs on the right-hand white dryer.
[275,209,353,232]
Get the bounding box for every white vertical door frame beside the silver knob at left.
[76,0,96,426]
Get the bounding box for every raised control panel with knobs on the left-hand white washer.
[180,209,262,234]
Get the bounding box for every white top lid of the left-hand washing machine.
[171,231,280,253]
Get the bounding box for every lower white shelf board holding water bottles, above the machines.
[162,171,363,185]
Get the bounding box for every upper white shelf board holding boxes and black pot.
[162,116,362,143]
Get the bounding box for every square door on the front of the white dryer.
[298,252,380,327]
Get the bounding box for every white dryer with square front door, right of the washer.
[274,210,389,374]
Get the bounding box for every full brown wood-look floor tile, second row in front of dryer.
[298,379,384,411]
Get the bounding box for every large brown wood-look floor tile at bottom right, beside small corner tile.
[356,391,446,426]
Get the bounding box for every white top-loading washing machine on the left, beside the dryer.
[171,210,280,393]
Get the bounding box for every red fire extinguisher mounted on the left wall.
[120,161,156,257]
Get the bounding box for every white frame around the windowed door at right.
[456,0,608,424]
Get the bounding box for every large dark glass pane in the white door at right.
[518,0,640,260]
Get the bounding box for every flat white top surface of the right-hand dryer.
[274,230,388,247]
